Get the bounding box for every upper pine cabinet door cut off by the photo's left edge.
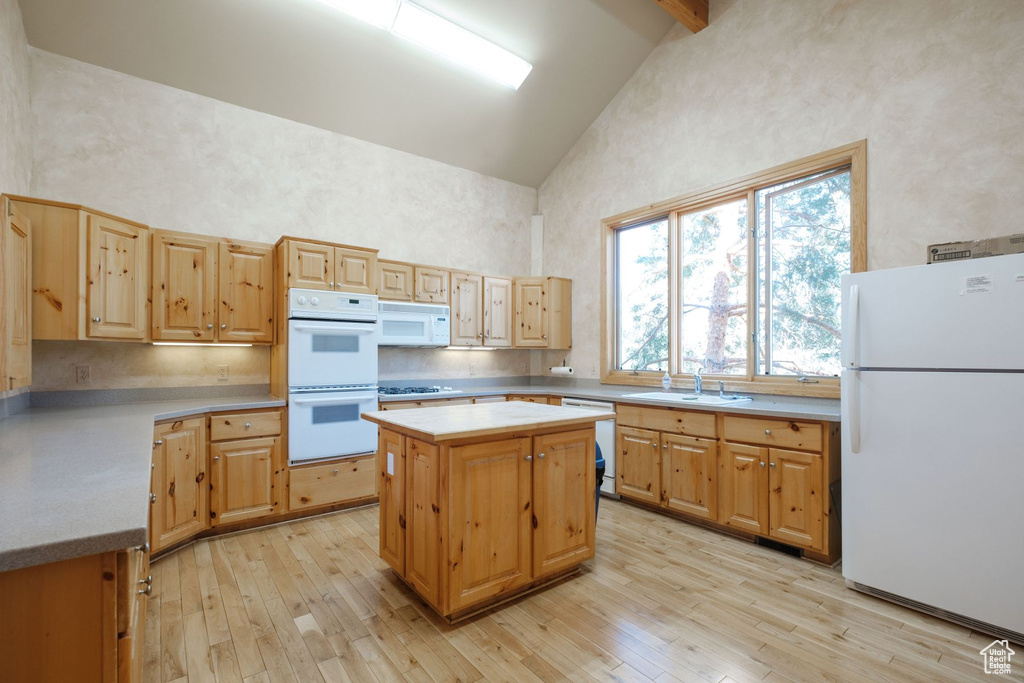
[0,200,32,391]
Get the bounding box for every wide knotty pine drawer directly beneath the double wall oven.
[288,455,377,510]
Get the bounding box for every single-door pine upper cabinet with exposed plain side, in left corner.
[14,198,150,341]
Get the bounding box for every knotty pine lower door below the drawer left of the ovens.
[210,437,281,526]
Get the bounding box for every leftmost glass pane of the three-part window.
[615,219,669,371]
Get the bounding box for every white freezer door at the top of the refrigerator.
[843,254,1024,370]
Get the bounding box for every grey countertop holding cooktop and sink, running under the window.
[380,382,840,422]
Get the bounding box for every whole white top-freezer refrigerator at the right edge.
[842,254,1024,642]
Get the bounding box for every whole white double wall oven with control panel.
[288,289,379,465]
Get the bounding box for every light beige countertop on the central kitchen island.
[362,401,615,443]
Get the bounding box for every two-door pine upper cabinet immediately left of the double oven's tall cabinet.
[153,230,273,343]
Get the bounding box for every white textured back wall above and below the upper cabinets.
[28,48,537,389]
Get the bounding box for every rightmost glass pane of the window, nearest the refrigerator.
[757,170,850,376]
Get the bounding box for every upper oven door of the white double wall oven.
[288,321,377,387]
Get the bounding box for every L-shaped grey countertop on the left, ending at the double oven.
[0,395,286,571]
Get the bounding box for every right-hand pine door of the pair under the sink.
[662,434,718,521]
